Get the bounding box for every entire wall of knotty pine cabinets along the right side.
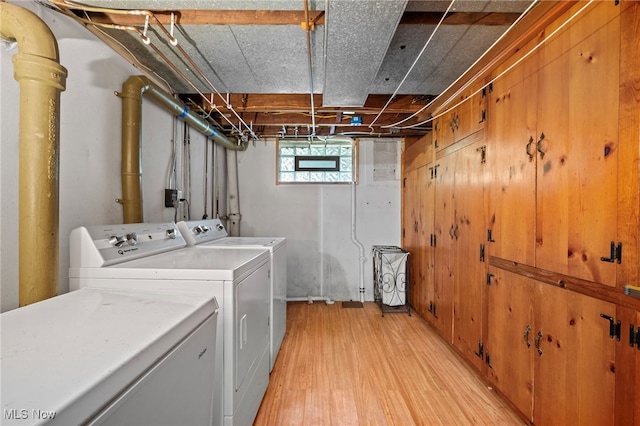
[400,2,640,426]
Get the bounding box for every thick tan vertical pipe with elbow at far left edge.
[0,2,67,306]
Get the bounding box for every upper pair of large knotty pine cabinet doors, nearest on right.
[487,2,624,286]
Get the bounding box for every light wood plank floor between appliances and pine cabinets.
[254,302,525,426]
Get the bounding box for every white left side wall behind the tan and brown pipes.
[0,1,212,311]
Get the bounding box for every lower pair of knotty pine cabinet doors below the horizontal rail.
[485,268,616,425]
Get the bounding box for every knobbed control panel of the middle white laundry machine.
[69,222,187,268]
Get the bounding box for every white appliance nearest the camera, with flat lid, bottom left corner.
[0,289,218,426]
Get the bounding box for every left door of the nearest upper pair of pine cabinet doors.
[487,43,537,266]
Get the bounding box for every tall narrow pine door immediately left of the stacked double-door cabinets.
[453,141,487,370]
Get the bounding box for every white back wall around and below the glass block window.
[238,139,400,301]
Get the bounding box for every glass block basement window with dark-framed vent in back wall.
[277,139,358,184]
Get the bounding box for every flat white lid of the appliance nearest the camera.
[0,288,218,425]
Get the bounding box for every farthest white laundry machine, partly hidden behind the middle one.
[178,219,287,371]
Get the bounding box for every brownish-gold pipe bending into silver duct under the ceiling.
[116,75,247,223]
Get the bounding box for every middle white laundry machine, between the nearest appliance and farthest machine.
[69,223,269,425]
